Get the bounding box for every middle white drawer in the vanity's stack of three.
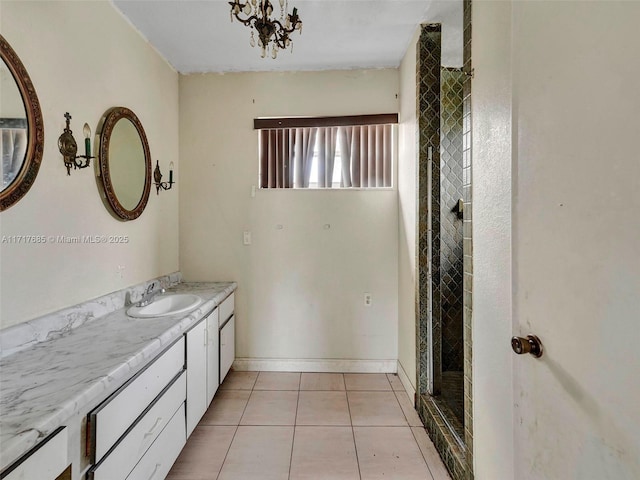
[89,372,187,480]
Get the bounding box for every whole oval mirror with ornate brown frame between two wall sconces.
[96,107,151,220]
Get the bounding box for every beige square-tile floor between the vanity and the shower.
[167,372,450,480]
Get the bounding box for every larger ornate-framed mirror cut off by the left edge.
[0,35,44,211]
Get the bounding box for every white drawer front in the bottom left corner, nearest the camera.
[2,428,68,480]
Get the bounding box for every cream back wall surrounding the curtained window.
[180,70,399,361]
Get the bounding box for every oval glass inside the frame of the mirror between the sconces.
[109,118,145,210]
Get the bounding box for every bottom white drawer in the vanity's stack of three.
[127,403,187,480]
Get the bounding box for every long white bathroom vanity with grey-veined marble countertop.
[0,282,236,480]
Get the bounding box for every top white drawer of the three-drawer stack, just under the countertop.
[90,338,184,463]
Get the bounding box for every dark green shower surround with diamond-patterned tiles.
[416,0,473,480]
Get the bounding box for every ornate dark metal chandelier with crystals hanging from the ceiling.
[229,0,302,58]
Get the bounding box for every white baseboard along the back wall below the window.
[233,358,398,374]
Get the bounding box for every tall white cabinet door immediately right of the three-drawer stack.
[186,320,207,437]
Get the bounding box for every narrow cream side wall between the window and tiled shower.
[398,28,420,391]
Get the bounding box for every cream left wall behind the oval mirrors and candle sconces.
[0,1,180,327]
